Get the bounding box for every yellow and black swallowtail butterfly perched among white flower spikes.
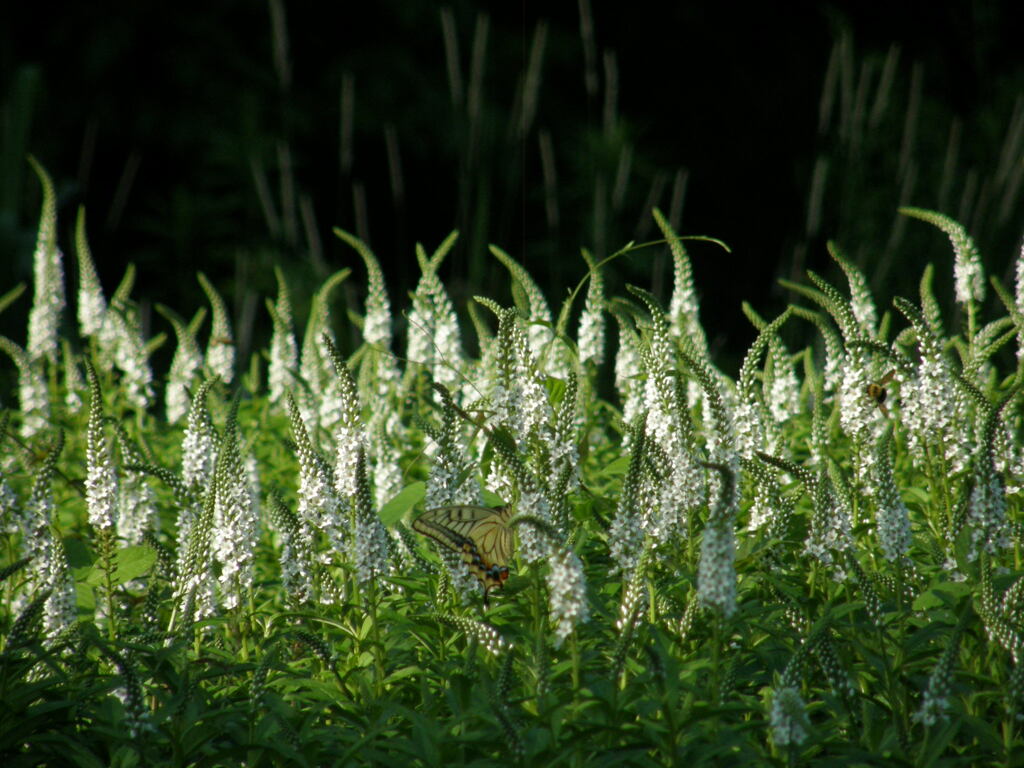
[413,504,515,602]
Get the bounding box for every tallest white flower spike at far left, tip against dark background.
[26,157,67,365]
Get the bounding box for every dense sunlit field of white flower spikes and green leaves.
[0,160,1024,766]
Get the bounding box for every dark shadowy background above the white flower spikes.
[0,0,1024,371]
